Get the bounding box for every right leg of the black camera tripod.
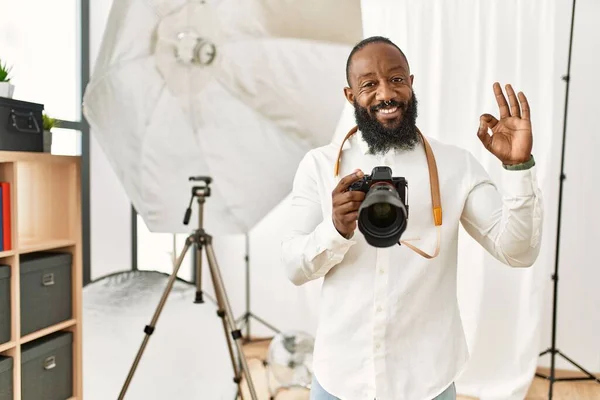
[205,241,258,400]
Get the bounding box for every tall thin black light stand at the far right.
[535,0,600,399]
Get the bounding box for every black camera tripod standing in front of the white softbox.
[119,176,258,400]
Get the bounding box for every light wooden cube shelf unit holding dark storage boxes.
[0,151,83,400]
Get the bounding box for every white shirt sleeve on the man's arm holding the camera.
[281,153,355,285]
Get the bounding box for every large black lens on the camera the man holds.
[358,184,408,247]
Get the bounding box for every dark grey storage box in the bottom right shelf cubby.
[21,332,73,400]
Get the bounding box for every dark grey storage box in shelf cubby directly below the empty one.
[19,252,73,336]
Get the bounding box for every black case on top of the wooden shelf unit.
[0,97,44,152]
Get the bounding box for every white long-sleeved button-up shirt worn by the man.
[281,132,542,400]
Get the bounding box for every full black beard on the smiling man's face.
[354,92,419,154]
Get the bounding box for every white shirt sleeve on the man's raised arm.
[461,156,543,267]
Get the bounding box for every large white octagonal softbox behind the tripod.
[84,0,362,234]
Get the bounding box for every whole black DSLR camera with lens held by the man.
[348,167,408,247]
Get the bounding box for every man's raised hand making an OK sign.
[477,82,533,165]
